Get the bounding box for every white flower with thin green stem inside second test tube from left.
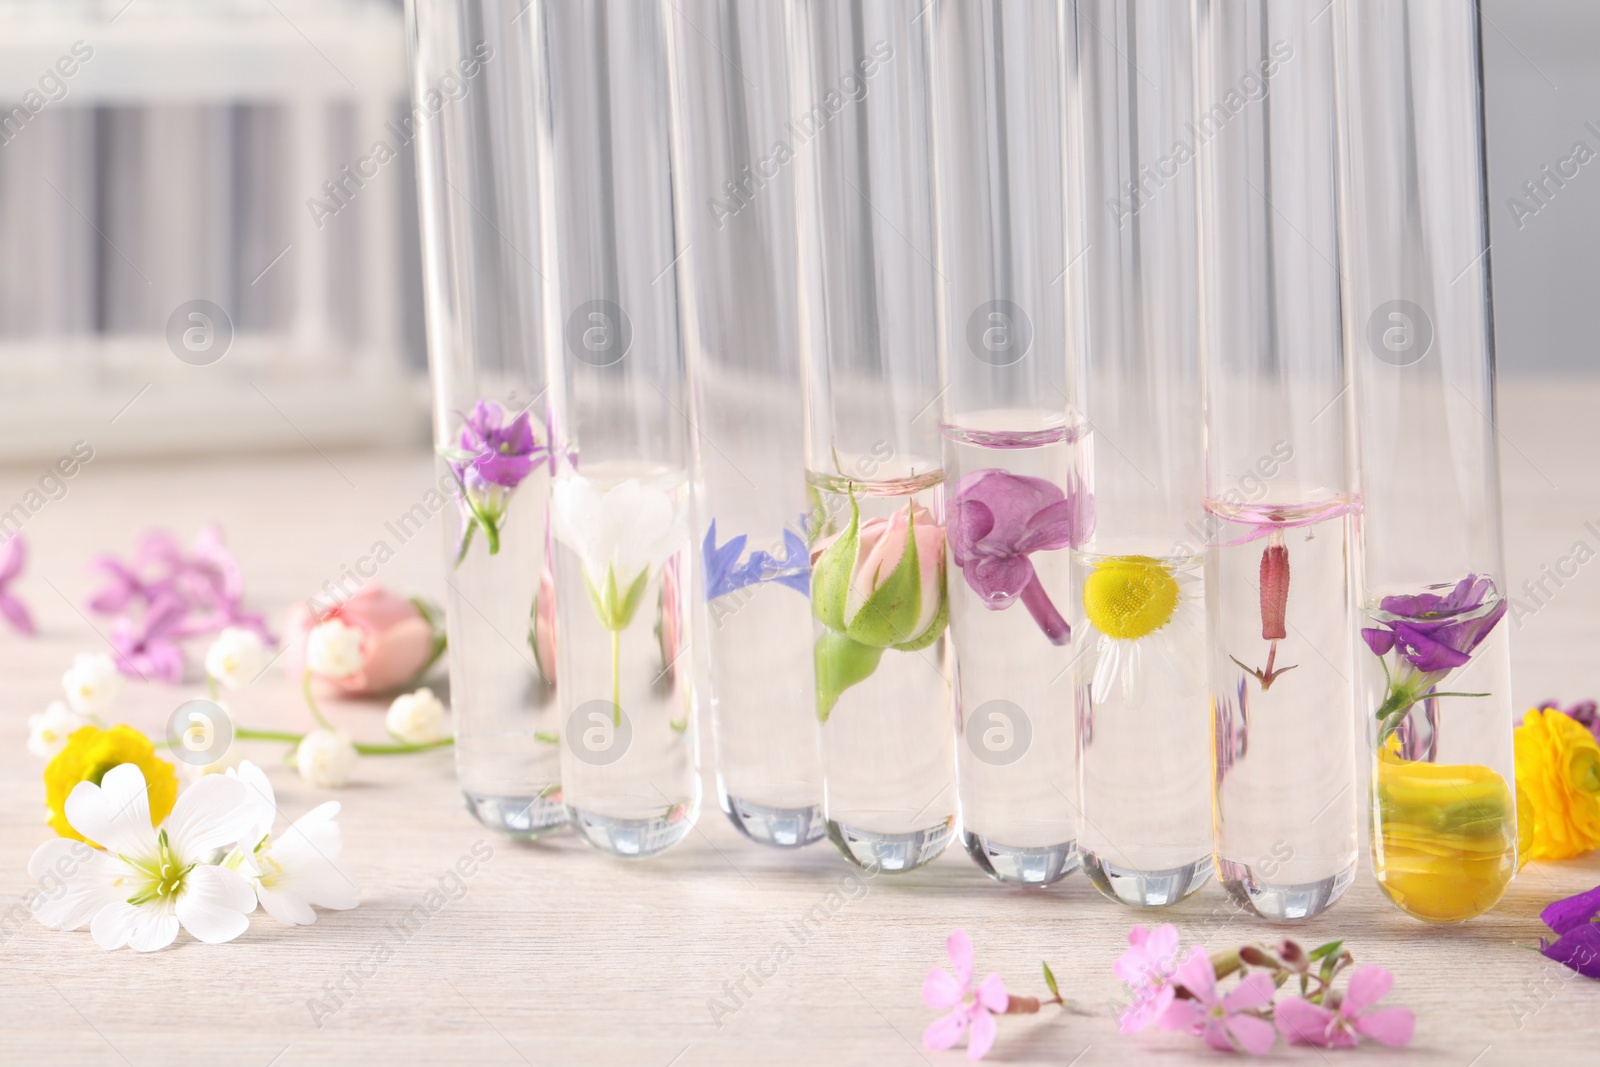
[550,474,686,725]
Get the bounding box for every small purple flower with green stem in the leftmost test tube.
[440,400,549,566]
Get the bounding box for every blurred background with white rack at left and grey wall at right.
[0,0,1600,462]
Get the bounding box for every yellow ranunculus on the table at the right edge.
[1517,707,1600,859]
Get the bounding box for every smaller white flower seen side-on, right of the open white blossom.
[222,760,362,926]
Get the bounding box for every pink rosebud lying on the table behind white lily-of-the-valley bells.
[283,584,440,696]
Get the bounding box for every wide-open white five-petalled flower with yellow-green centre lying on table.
[27,763,256,952]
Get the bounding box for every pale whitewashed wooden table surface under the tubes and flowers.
[0,379,1600,1067]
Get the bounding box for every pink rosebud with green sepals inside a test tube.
[811,490,949,723]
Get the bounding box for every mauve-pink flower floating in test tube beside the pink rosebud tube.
[949,467,1094,645]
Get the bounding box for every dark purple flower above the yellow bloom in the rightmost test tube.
[1362,574,1507,734]
